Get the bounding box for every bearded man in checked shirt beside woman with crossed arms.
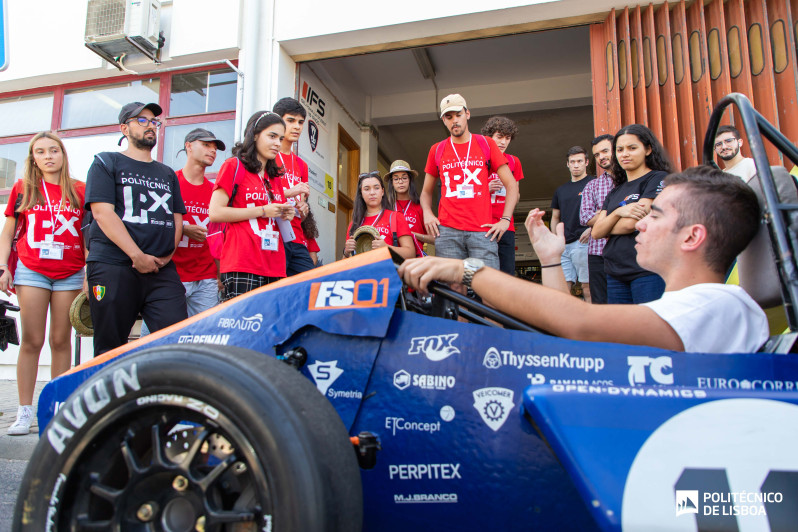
[579,135,615,303]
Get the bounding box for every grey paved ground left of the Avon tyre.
[0,380,46,532]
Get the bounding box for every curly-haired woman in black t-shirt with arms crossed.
[592,124,671,304]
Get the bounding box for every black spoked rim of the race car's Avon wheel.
[58,392,272,532]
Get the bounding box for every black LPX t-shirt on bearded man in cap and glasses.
[86,152,186,264]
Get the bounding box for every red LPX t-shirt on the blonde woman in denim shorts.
[6,181,86,279]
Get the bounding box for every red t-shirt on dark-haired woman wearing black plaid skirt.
[213,157,285,277]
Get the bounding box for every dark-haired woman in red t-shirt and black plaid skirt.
[209,111,294,300]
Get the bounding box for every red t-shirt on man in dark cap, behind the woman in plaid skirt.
[172,169,216,283]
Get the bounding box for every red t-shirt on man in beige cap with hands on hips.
[424,135,507,231]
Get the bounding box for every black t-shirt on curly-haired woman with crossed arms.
[602,170,668,282]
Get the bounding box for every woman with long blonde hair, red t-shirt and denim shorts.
[0,132,86,435]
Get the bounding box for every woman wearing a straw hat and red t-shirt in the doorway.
[384,160,435,257]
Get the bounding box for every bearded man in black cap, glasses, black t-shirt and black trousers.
[86,102,186,356]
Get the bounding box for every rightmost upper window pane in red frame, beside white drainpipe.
[169,69,238,116]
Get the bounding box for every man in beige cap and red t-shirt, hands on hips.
[421,94,518,268]
